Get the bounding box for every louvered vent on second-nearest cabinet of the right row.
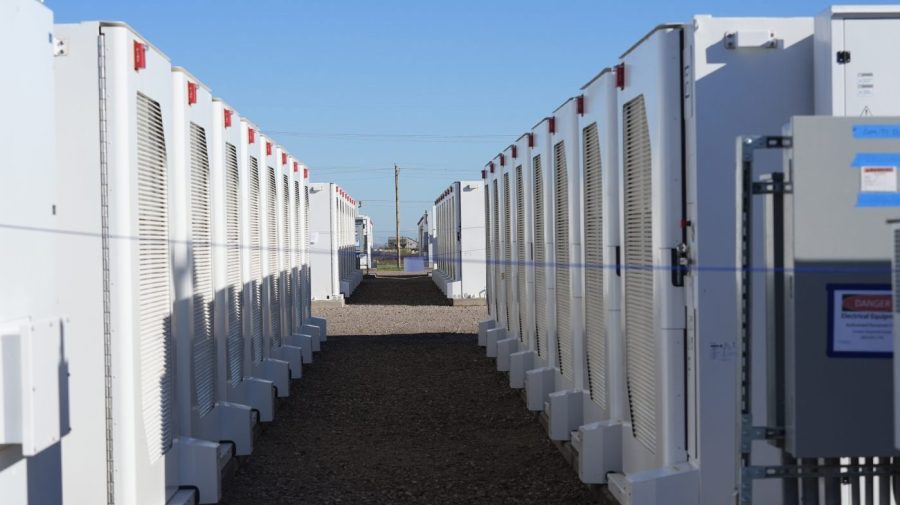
[582,123,607,409]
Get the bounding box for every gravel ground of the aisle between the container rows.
[222,277,600,505]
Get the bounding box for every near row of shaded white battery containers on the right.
[478,7,900,504]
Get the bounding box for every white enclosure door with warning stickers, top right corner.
[831,19,900,117]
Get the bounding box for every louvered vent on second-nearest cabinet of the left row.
[190,123,216,416]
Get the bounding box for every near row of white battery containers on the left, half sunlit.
[0,17,325,504]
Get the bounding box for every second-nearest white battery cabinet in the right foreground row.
[572,68,626,484]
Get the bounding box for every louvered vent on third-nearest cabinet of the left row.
[225,143,244,386]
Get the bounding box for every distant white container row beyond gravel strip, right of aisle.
[428,181,485,299]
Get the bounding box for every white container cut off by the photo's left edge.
[0,0,67,505]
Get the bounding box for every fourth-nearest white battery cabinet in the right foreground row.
[525,118,557,411]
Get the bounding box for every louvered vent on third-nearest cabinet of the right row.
[553,142,574,379]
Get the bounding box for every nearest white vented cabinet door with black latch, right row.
[618,28,686,472]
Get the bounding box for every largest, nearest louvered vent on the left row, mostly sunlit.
[136,93,174,462]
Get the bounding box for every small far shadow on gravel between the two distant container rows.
[346,274,451,306]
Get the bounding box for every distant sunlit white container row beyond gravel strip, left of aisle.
[309,182,362,300]
